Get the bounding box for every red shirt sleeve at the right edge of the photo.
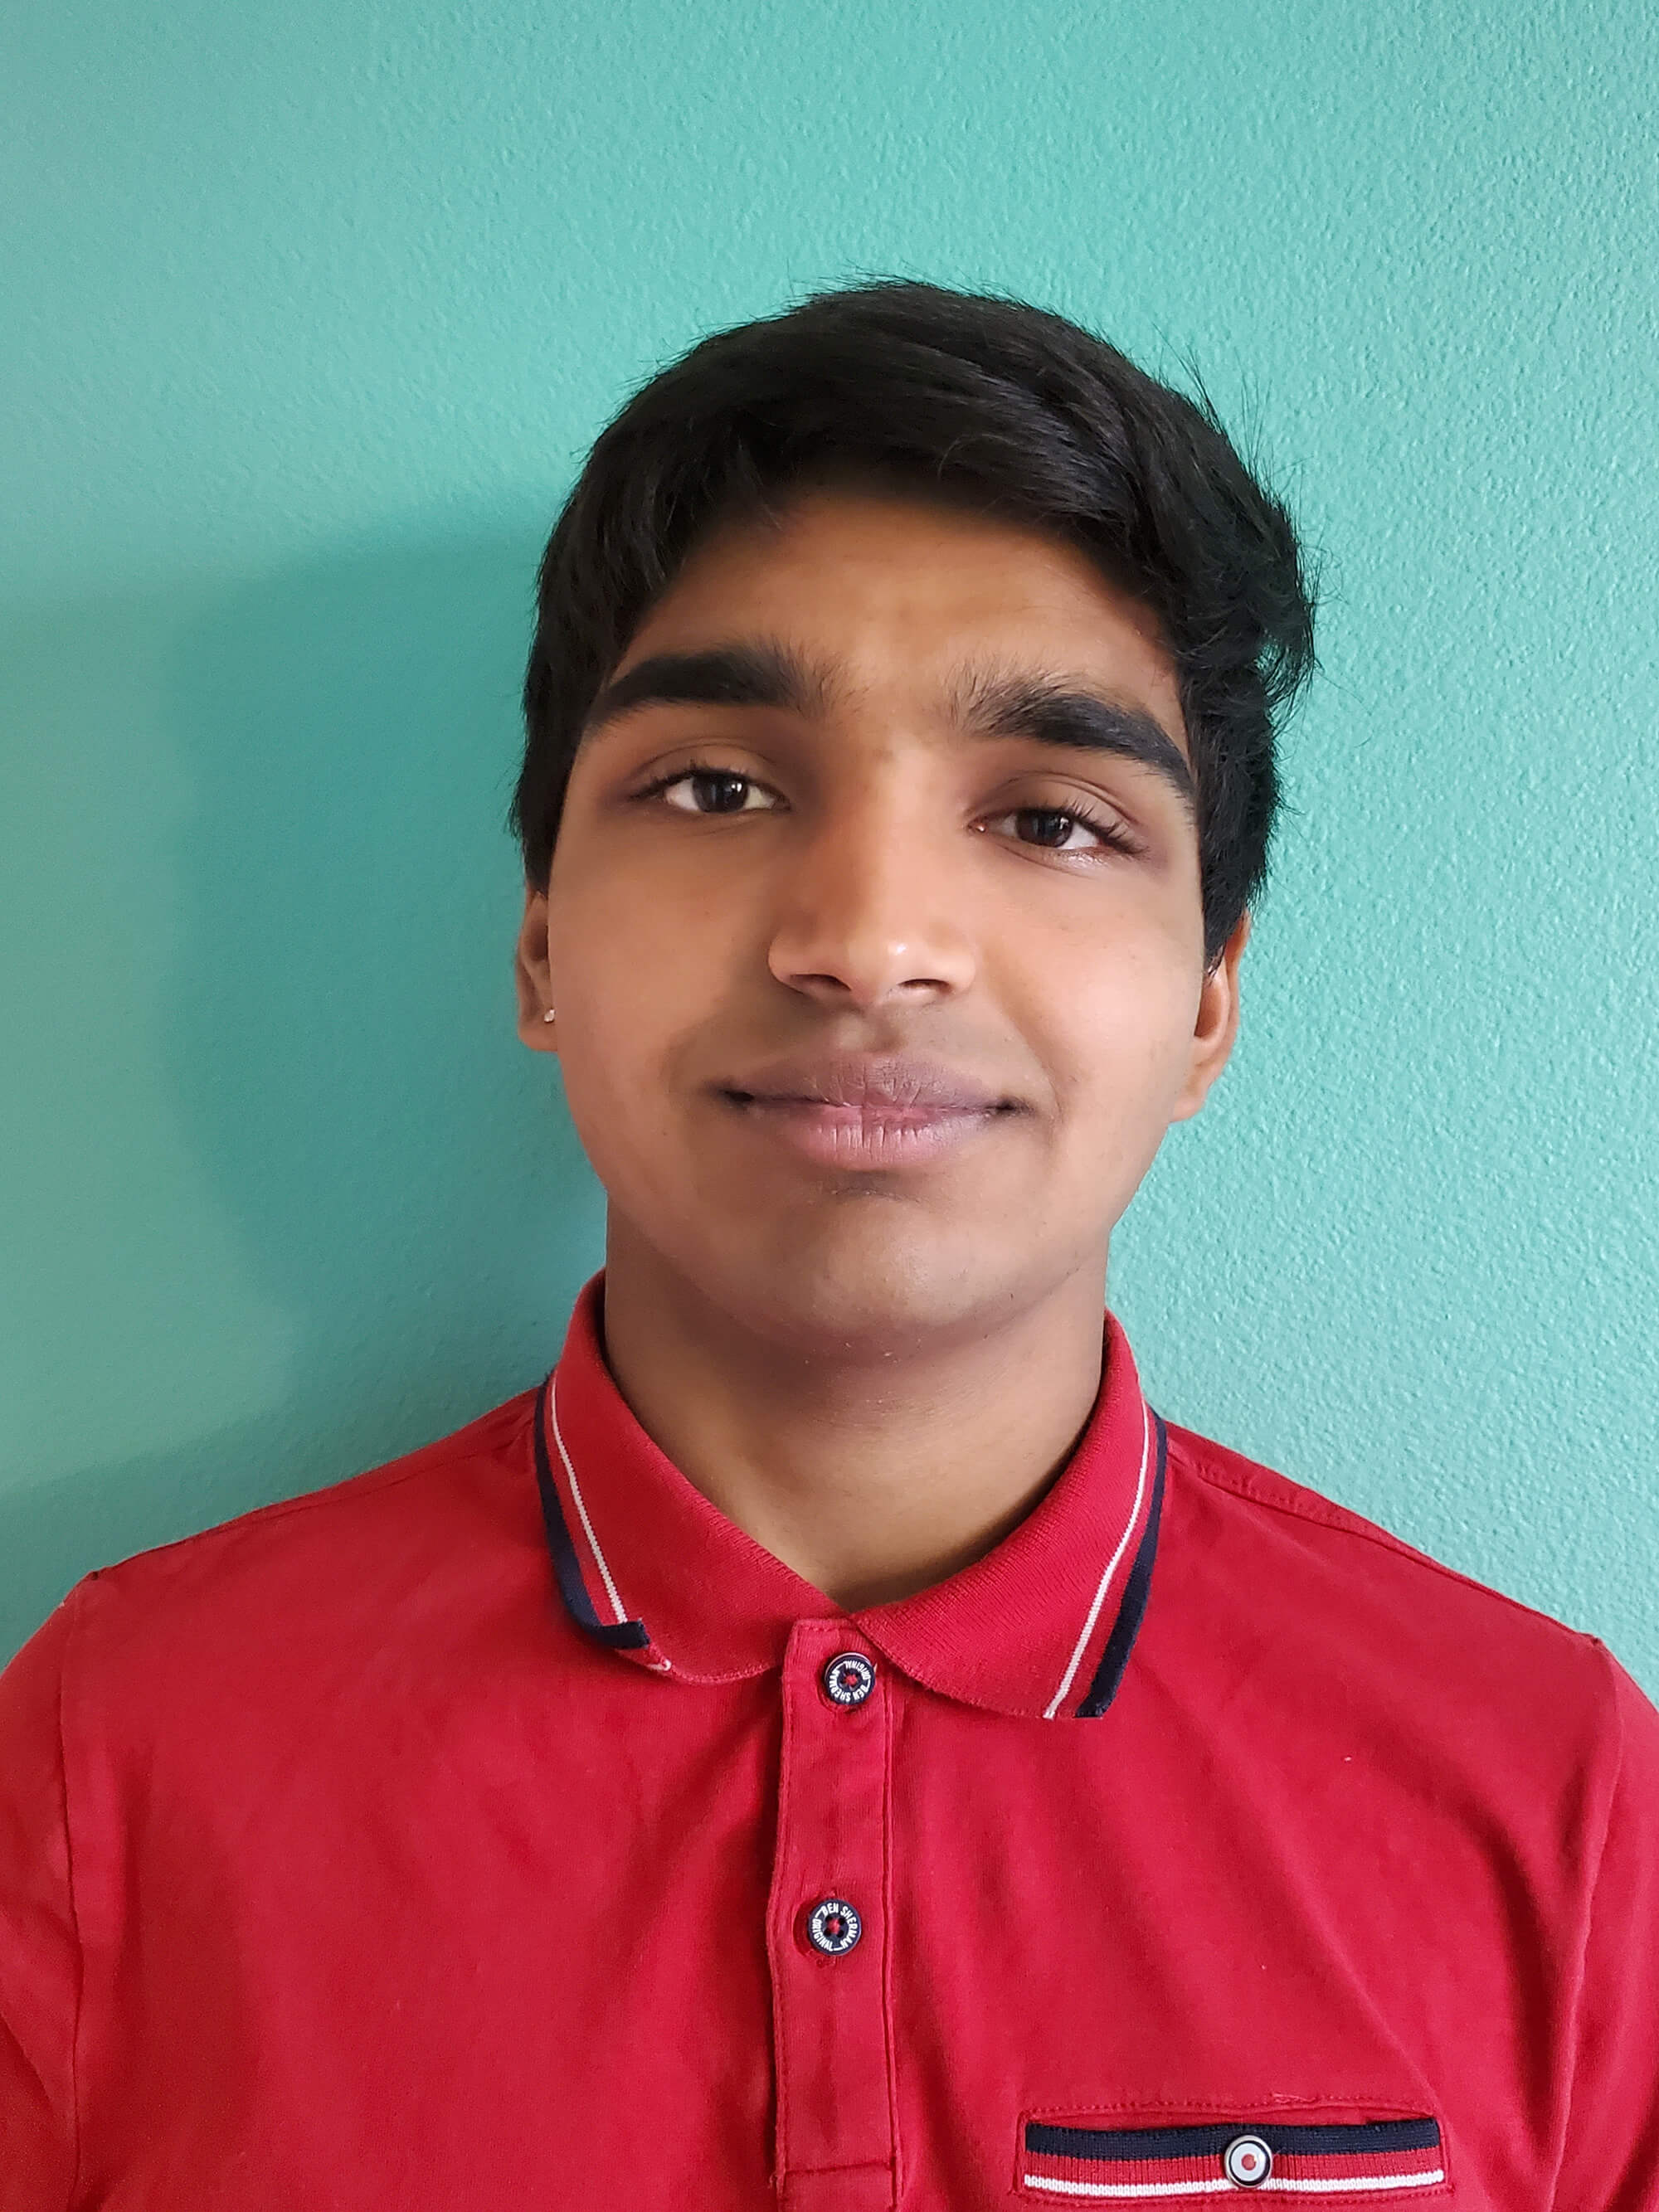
[1555,1661,1659,2212]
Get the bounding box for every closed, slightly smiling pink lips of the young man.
[717,1053,1018,1173]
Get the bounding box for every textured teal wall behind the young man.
[0,0,1659,1688]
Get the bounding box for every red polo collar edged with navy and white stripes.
[533,1276,1165,1719]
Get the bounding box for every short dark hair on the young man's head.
[511,281,1314,960]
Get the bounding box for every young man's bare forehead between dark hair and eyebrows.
[615,491,1185,750]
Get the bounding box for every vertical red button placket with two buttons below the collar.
[767,1621,896,2212]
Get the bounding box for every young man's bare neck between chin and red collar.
[604,1223,1104,1612]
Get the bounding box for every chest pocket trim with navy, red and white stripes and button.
[1019,2117,1451,2205]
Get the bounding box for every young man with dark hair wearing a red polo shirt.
[0,285,1659,2212]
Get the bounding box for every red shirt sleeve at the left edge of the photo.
[0,1597,80,2212]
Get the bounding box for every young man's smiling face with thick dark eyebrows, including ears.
[518,493,1243,1356]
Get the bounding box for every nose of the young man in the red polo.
[767,779,978,1011]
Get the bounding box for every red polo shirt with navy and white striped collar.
[0,1290,1659,2212]
